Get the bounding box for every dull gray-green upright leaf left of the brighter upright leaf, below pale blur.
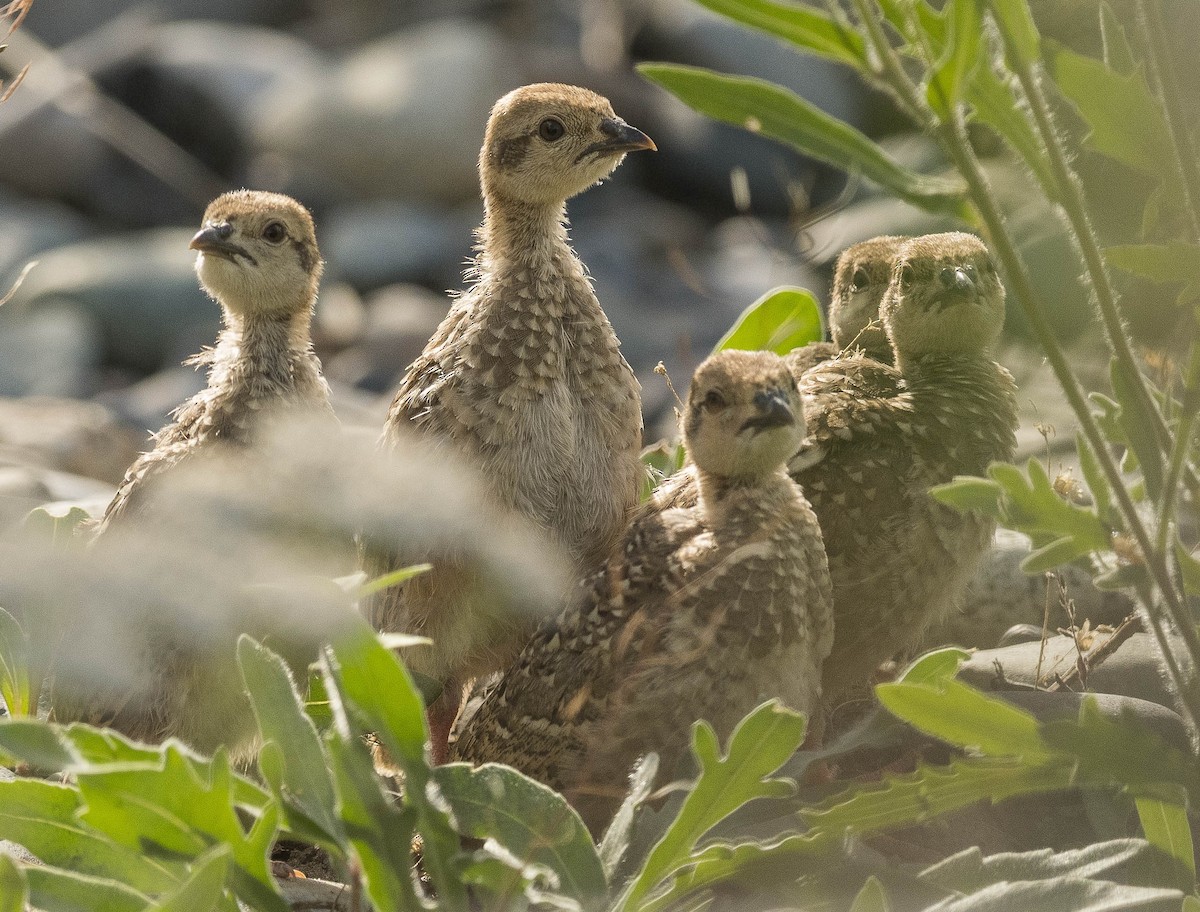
[238,635,342,842]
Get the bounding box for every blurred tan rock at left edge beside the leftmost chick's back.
[0,397,143,484]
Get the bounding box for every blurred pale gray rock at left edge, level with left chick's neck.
[0,304,102,397]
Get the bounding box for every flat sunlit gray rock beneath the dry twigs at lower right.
[959,634,1175,709]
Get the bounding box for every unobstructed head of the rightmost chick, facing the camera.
[881,232,1004,361]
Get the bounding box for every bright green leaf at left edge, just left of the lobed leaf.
[0,779,182,893]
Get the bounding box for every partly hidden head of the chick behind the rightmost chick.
[829,235,908,360]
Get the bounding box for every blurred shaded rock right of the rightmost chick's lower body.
[923,529,1134,648]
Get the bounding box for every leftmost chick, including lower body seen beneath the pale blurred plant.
[64,190,332,750]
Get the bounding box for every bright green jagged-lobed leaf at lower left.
[77,743,287,912]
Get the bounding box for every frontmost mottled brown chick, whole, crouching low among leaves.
[454,352,833,832]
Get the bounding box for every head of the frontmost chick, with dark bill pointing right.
[684,350,805,478]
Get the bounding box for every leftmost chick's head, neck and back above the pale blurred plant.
[88,190,332,535]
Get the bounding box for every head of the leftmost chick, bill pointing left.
[187,190,323,316]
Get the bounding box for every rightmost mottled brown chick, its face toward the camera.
[655,233,1016,701]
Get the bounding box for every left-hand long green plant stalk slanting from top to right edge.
[854,0,1200,740]
